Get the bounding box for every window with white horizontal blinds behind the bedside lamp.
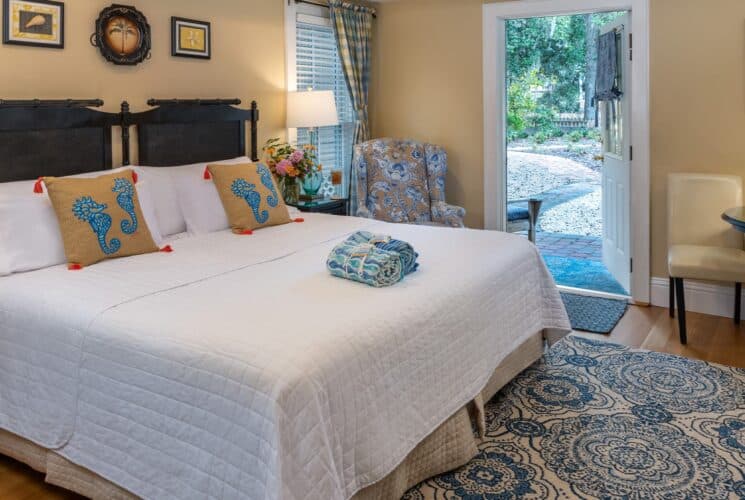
[295,14,355,196]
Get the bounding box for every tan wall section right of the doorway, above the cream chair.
[651,0,745,276]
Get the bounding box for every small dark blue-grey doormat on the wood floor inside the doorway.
[561,293,629,333]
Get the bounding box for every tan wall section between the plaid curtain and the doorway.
[370,0,484,227]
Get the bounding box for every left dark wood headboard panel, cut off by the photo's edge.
[0,99,120,182]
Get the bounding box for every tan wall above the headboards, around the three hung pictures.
[0,0,285,164]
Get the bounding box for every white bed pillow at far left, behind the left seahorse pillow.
[0,168,162,276]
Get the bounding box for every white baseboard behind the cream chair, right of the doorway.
[651,278,745,318]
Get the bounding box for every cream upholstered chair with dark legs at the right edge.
[667,174,745,344]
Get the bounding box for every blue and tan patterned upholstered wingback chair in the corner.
[351,139,466,227]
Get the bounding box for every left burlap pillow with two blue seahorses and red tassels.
[43,170,158,269]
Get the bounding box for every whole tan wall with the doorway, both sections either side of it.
[371,0,745,276]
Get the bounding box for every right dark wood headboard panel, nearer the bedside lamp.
[122,99,259,167]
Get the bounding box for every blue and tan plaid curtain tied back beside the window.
[329,0,375,144]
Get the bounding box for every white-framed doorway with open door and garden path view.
[484,0,649,303]
